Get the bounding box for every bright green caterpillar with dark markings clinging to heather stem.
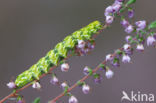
[15,21,102,88]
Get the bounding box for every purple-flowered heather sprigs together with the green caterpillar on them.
[0,0,156,103]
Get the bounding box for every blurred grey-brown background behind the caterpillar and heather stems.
[0,0,156,103]
